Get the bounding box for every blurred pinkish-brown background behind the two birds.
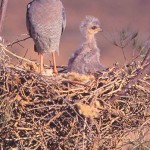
[2,0,150,66]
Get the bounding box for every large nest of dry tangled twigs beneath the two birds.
[0,42,150,150]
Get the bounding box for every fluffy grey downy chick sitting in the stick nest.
[68,16,105,74]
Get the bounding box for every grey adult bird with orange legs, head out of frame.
[26,0,66,73]
